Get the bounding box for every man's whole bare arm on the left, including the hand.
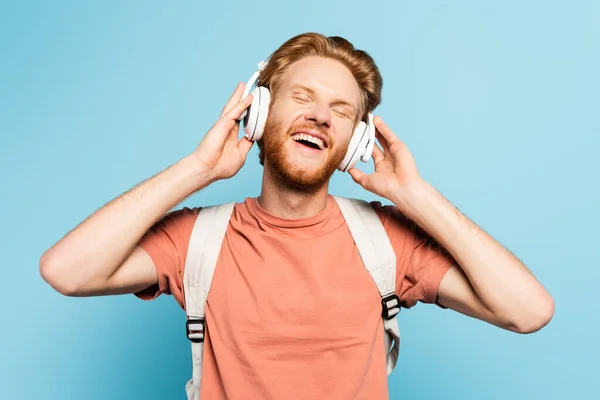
[40,84,252,296]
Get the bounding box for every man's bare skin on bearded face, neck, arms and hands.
[40,57,554,333]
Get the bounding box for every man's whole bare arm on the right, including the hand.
[350,117,554,333]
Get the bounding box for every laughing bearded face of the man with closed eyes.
[263,57,361,190]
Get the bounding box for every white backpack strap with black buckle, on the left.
[183,203,235,400]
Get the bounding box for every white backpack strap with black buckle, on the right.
[334,196,400,375]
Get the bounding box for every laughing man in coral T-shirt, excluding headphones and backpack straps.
[40,34,554,399]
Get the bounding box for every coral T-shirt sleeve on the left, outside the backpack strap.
[134,207,200,308]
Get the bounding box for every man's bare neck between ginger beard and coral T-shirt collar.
[258,166,329,219]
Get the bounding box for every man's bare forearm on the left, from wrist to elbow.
[40,157,209,288]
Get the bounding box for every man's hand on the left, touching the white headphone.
[193,83,253,182]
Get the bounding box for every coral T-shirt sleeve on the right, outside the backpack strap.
[371,202,456,308]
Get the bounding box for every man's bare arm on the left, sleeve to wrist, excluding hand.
[40,157,208,296]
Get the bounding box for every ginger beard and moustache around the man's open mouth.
[262,118,346,192]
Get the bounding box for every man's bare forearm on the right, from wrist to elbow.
[394,182,552,326]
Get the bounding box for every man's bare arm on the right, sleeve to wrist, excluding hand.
[392,182,554,333]
